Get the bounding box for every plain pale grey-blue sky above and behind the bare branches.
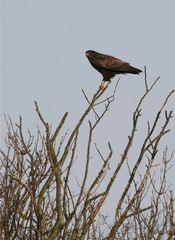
[1,0,175,220]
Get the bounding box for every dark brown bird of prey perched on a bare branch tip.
[85,50,142,90]
